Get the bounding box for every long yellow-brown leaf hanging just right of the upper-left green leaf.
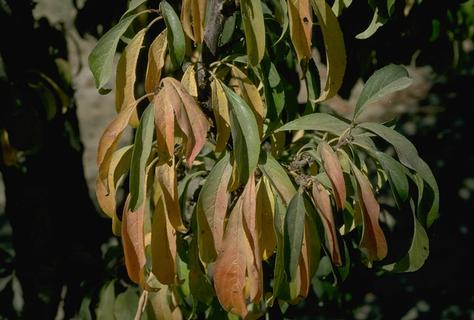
[115,29,146,127]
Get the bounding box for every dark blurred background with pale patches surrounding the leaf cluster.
[0,0,474,320]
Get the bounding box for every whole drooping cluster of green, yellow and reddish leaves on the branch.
[89,0,439,319]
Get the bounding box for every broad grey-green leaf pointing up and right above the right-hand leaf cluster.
[354,64,412,120]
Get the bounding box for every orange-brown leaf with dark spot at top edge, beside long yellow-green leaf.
[288,0,313,61]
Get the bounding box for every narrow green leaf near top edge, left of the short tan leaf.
[160,0,186,70]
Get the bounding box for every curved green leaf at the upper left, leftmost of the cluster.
[89,13,140,93]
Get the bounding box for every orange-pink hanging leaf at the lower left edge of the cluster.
[121,195,146,284]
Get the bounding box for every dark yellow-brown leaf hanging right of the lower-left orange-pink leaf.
[151,181,176,284]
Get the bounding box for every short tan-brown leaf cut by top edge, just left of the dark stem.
[181,0,207,44]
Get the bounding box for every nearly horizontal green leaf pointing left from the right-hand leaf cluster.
[275,113,349,135]
